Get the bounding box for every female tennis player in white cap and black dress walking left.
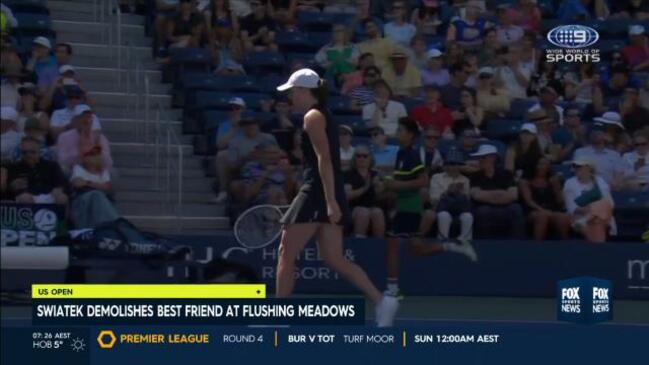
[276,68,399,327]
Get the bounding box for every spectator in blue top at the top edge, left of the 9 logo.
[446,0,492,48]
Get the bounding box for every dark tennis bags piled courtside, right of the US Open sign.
[52,218,259,283]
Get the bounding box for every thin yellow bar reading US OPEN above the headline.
[32,284,266,300]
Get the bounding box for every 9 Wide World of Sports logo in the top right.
[546,24,600,62]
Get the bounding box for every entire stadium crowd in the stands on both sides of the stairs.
[2,0,649,242]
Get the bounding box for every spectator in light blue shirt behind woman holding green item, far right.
[573,128,624,190]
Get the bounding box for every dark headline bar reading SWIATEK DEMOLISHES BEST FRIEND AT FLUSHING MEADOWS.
[32,298,365,326]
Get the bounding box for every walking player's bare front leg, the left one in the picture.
[275,223,318,298]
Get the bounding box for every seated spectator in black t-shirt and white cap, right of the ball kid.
[471,144,525,239]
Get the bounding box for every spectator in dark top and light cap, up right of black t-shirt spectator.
[505,123,543,179]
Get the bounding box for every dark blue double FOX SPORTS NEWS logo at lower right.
[557,277,613,324]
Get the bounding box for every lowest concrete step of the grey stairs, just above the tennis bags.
[124,215,230,234]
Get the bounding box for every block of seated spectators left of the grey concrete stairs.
[0,4,118,228]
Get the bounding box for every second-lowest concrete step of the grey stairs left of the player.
[116,202,225,217]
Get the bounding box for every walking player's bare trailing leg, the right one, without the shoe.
[317,224,383,304]
